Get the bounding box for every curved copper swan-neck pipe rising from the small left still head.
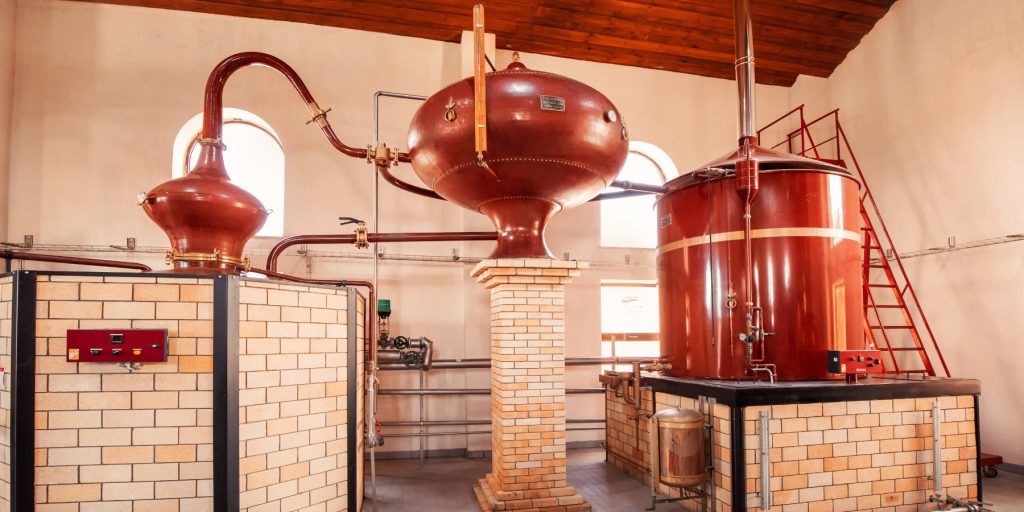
[203,51,367,158]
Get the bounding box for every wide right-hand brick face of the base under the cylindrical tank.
[744,395,978,512]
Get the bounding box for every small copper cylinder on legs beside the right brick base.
[651,409,708,487]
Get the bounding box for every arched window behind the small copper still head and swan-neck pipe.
[171,109,285,237]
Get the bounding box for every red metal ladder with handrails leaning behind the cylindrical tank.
[758,105,949,377]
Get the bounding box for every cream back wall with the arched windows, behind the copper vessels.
[0,0,788,456]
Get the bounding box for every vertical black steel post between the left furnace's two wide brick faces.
[213,275,240,512]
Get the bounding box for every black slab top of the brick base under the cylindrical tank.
[643,376,981,408]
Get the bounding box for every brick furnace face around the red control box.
[35,275,213,512]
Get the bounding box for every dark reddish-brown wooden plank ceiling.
[72,0,895,86]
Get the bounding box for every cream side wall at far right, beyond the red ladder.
[811,0,1024,464]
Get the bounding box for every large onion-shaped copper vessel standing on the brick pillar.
[409,61,629,258]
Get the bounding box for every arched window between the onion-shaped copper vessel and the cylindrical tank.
[601,141,679,249]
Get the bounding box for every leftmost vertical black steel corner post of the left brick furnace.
[10,270,36,512]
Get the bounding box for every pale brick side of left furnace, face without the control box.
[239,280,350,512]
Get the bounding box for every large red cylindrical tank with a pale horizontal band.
[656,146,864,380]
